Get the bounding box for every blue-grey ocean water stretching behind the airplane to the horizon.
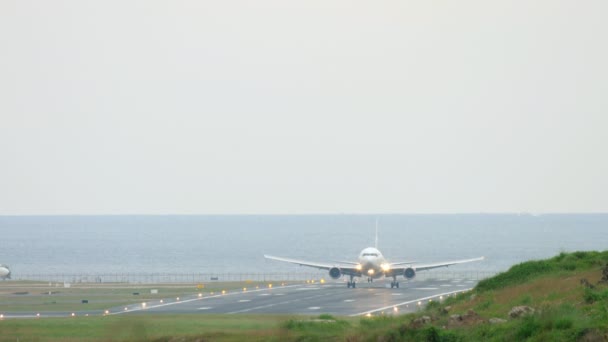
[0,214,608,278]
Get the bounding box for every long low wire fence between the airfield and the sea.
[13,270,496,284]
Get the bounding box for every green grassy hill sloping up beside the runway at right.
[345,251,608,341]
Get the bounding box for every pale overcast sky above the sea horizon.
[0,0,608,215]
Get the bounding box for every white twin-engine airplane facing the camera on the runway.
[264,224,484,288]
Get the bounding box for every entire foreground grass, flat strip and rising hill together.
[0,252,608,342]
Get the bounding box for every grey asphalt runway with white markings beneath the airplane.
[106,279,476,316]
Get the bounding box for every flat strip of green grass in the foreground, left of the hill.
[0,314,356,342]
